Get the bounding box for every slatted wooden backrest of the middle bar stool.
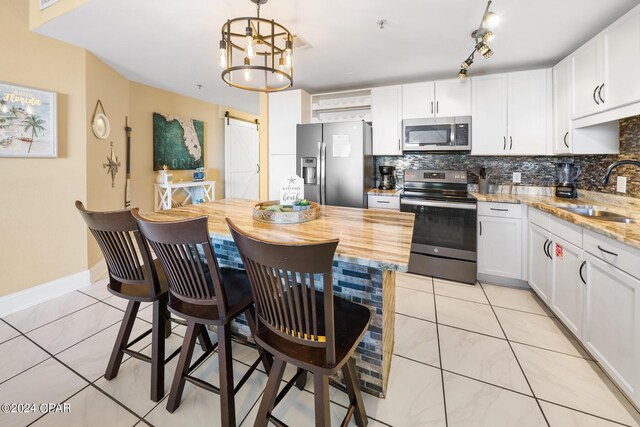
[132,209,228,316]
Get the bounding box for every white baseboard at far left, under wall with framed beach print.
[0,270,90,317]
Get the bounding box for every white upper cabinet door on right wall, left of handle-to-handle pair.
[571,37,603,119]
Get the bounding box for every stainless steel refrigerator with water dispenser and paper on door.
[296,121,375,208]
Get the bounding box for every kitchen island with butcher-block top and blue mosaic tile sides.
[143,199,414,397]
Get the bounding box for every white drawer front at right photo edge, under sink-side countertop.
[584,230,640,278]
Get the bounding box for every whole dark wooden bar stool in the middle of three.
[133,209,272,427]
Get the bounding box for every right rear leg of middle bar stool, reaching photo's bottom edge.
[218,323,236,427]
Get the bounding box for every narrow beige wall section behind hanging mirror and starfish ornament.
[85,52,129,267]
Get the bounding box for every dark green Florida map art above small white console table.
[153,113,204,171]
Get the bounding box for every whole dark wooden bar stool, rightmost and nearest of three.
[227,218,371,427]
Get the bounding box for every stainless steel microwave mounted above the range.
[402,116,471,151]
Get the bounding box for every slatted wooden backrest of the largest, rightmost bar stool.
[226,218,339,365]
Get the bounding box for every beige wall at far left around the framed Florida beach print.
[0,0,87,295]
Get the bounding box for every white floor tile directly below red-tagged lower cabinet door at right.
[495,307,589,358]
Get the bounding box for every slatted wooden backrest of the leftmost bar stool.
[76,200,161,293]
